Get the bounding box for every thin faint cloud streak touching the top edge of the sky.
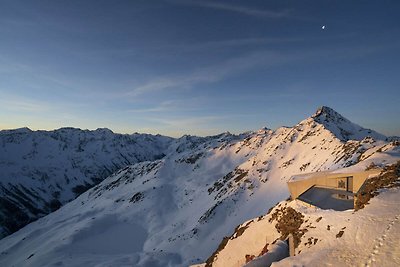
[170,0,290,19]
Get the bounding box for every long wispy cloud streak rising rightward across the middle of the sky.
[123,38,386,97]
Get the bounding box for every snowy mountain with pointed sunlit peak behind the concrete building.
[0,107,398,266]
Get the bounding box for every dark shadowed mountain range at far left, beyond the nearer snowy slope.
[0,128,172,237]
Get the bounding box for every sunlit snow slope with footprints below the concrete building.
[273,188,400,267]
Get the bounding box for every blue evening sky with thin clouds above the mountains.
[0,0,400,137]
